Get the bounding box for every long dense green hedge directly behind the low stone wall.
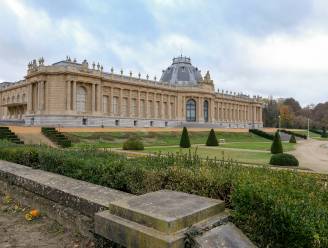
[0,144,328,248]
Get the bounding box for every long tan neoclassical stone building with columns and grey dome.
[0,56,262,128]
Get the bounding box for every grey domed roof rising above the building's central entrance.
[160,55,203,86]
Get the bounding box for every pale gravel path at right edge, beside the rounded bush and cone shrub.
[290,139,328,174]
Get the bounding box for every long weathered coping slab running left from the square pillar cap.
[0,160,133,218]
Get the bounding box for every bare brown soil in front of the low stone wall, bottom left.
[0,195,94,248]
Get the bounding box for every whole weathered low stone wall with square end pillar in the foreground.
[0,160,254,248]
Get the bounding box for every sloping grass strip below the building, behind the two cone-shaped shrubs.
[65,131,267,148]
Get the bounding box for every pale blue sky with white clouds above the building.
[0,0,328,105]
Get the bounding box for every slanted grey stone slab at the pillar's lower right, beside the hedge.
[195,223,256,248]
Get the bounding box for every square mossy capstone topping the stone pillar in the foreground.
[109,190,225,234]
